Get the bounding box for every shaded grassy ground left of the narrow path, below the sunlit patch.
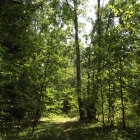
[0,122,66,140]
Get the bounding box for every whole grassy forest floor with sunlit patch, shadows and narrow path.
[0,114,140,140]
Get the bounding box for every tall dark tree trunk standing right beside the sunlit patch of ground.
[74,0,85,120]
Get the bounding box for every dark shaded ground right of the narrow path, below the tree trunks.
[64,122,140,140]
